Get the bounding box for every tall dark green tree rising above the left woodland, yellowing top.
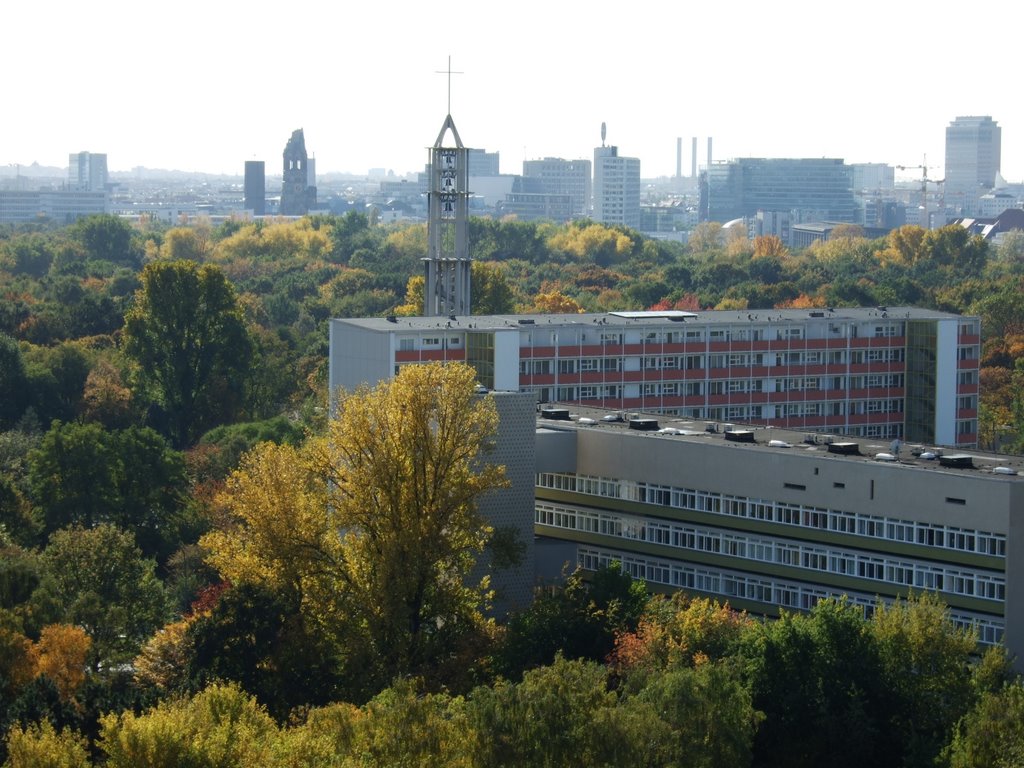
[123,261,252,446]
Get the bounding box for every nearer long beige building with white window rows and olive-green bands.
[535,408,1024,655]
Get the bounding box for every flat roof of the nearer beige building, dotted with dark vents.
[537,402,1024,481]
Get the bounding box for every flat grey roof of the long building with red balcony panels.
[334,306,961,332]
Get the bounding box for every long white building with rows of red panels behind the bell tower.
[330,307,981,447]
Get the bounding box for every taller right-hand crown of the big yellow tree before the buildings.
[313,364,506,688]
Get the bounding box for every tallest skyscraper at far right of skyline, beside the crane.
[944,115,1002,213]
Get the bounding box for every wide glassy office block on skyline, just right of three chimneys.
[700,158,858,223]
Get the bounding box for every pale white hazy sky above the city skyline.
[0,0,1024,181]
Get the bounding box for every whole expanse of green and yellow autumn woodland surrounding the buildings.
[6,213,1024,766]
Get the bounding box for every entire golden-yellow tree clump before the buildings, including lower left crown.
[202,364,506,689]
